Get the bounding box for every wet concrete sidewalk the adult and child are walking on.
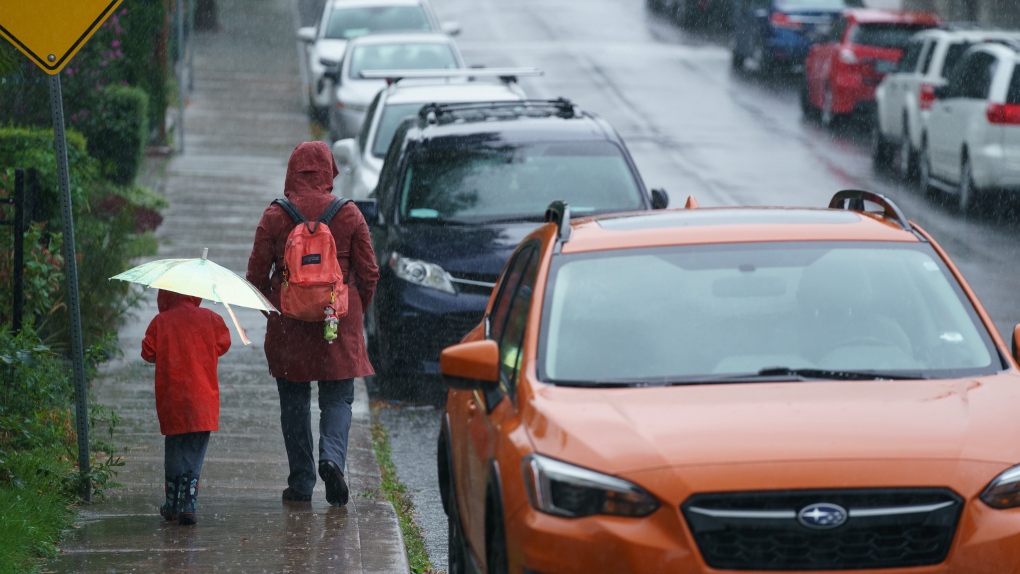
[46,0,409,574]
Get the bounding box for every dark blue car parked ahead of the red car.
[731,0,864,73]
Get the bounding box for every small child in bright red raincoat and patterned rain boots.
[142,290,231,525]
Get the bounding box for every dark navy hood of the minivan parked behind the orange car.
[390,221,541,282]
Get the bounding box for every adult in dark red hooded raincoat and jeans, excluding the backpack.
[247,142,379,505]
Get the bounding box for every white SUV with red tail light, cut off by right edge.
[918,42,1020,212]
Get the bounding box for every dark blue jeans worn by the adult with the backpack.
[276,378,354,494]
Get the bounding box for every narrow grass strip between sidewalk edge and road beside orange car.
[371,405,439,574]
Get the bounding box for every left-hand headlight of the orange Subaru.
[522,455,659,518]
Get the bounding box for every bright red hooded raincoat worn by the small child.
[142,290,231,434]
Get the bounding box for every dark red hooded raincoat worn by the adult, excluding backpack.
[247,142,379,382]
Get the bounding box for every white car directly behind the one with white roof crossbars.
[326,33,465,142]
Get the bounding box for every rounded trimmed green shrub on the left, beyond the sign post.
[82,86,149,186]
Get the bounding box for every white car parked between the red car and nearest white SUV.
[871,28,1020,181]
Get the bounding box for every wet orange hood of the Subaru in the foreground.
[523,373,1020,474]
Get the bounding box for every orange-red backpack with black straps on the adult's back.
[272,198,351,322]
